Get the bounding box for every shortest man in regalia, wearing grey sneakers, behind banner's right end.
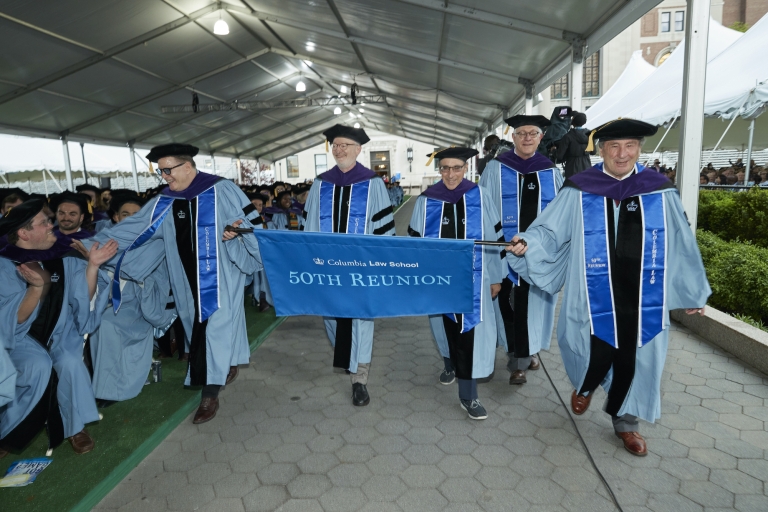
[408,147,506,420]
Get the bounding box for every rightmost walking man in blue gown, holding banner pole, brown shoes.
[507,119,711,456]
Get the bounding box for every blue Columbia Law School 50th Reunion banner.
[254,230,474,318]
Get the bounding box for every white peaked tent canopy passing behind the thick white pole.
[587,20,740,128]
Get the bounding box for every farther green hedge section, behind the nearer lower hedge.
[698,187,768,248]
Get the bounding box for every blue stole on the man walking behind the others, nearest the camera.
[499,164,557,285]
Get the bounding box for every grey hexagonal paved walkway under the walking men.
[98,317,768,512]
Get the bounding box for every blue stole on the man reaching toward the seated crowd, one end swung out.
[112,187,219,323]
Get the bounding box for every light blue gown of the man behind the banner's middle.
[304,171,395,373]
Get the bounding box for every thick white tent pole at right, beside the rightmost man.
[677,1,710,235]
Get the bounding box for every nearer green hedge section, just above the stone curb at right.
[696,230,768,324]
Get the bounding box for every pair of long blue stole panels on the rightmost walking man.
[581,192,667,348]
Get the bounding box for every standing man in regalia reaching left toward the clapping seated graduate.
[88,144,261,424]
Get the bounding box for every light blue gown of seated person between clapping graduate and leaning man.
[90,263,176,401]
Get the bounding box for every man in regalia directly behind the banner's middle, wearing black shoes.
[304,124,395,406]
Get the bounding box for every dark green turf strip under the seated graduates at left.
[0,304,283,512]
